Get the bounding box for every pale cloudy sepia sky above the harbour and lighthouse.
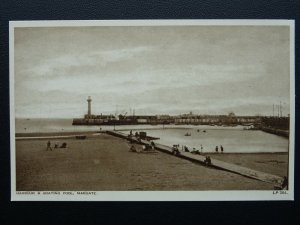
[14,26,290,118]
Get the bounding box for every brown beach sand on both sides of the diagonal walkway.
[16,134,288,191]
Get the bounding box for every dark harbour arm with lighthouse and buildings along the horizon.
[72,96,290,138]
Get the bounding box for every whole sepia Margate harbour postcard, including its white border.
[9,20,295,201]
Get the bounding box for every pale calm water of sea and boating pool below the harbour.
[15,119,289,153]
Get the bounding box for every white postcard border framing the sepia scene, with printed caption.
[9,20,295,201]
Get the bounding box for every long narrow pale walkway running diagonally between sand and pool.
[106,131,283,186]
